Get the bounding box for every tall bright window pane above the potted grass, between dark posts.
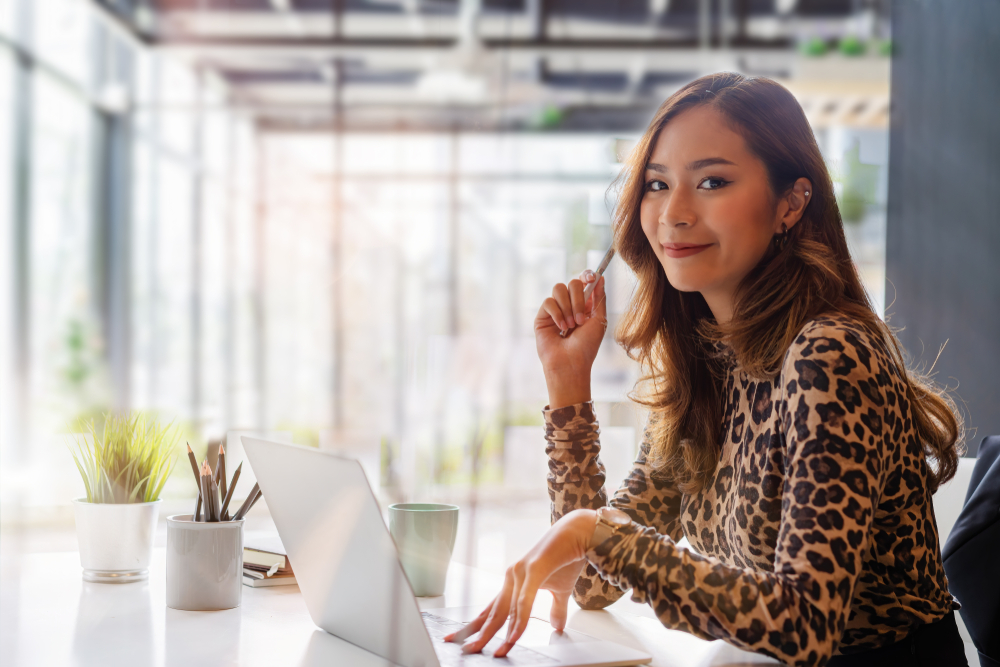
[29,73,97,429]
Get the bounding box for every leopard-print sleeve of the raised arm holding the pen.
[543,402,683,609]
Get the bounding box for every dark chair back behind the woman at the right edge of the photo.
[941,435,1000,667]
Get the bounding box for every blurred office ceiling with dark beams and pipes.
[92,0,888,130]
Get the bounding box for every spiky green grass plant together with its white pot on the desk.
[72,413,176,583]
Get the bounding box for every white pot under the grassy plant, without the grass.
[73,498,162,583]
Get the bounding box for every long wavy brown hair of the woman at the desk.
[614,72,964,493]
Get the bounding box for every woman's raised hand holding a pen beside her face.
[535,269,608,410]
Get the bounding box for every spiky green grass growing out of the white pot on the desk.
[71,412,177,504]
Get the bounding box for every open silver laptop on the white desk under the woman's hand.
[242,436,652,667]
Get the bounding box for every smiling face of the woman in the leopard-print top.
[640,106,804,322]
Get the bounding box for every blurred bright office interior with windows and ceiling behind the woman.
[0,0,904,569]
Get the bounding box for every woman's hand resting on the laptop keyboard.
[444,510,597,658]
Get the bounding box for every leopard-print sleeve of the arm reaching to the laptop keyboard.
[587,327,892,665]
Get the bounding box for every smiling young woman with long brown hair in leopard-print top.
[447,74,967,667]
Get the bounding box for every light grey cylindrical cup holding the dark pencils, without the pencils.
[167,514,243,611]
